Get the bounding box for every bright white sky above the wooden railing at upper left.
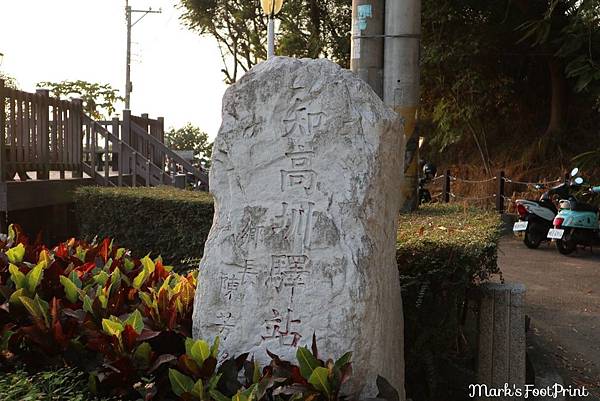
[0,0,226,138]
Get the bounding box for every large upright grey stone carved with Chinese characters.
[194,57,404,399]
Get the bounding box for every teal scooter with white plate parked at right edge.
[548,168,600,255]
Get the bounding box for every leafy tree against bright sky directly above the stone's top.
[180,0,352,84]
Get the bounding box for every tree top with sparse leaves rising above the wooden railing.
[37,80,124,120]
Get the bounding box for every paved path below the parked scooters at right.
[498,236,600,400]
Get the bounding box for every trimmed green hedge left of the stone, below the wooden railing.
[75,187,214,268]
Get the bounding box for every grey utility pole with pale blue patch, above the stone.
[350,0,385,99]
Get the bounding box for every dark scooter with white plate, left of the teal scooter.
[513,183,570,249]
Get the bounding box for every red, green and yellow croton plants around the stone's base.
[0,225,390,401]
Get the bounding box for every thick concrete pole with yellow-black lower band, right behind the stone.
[383,0,421,211]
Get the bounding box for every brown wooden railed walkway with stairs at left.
[0,80,208,212]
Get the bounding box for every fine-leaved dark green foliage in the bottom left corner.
[0,368,116,401]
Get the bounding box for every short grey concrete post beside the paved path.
[477,283,526,400]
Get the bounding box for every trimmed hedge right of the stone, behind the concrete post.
[397,205,501,401]
